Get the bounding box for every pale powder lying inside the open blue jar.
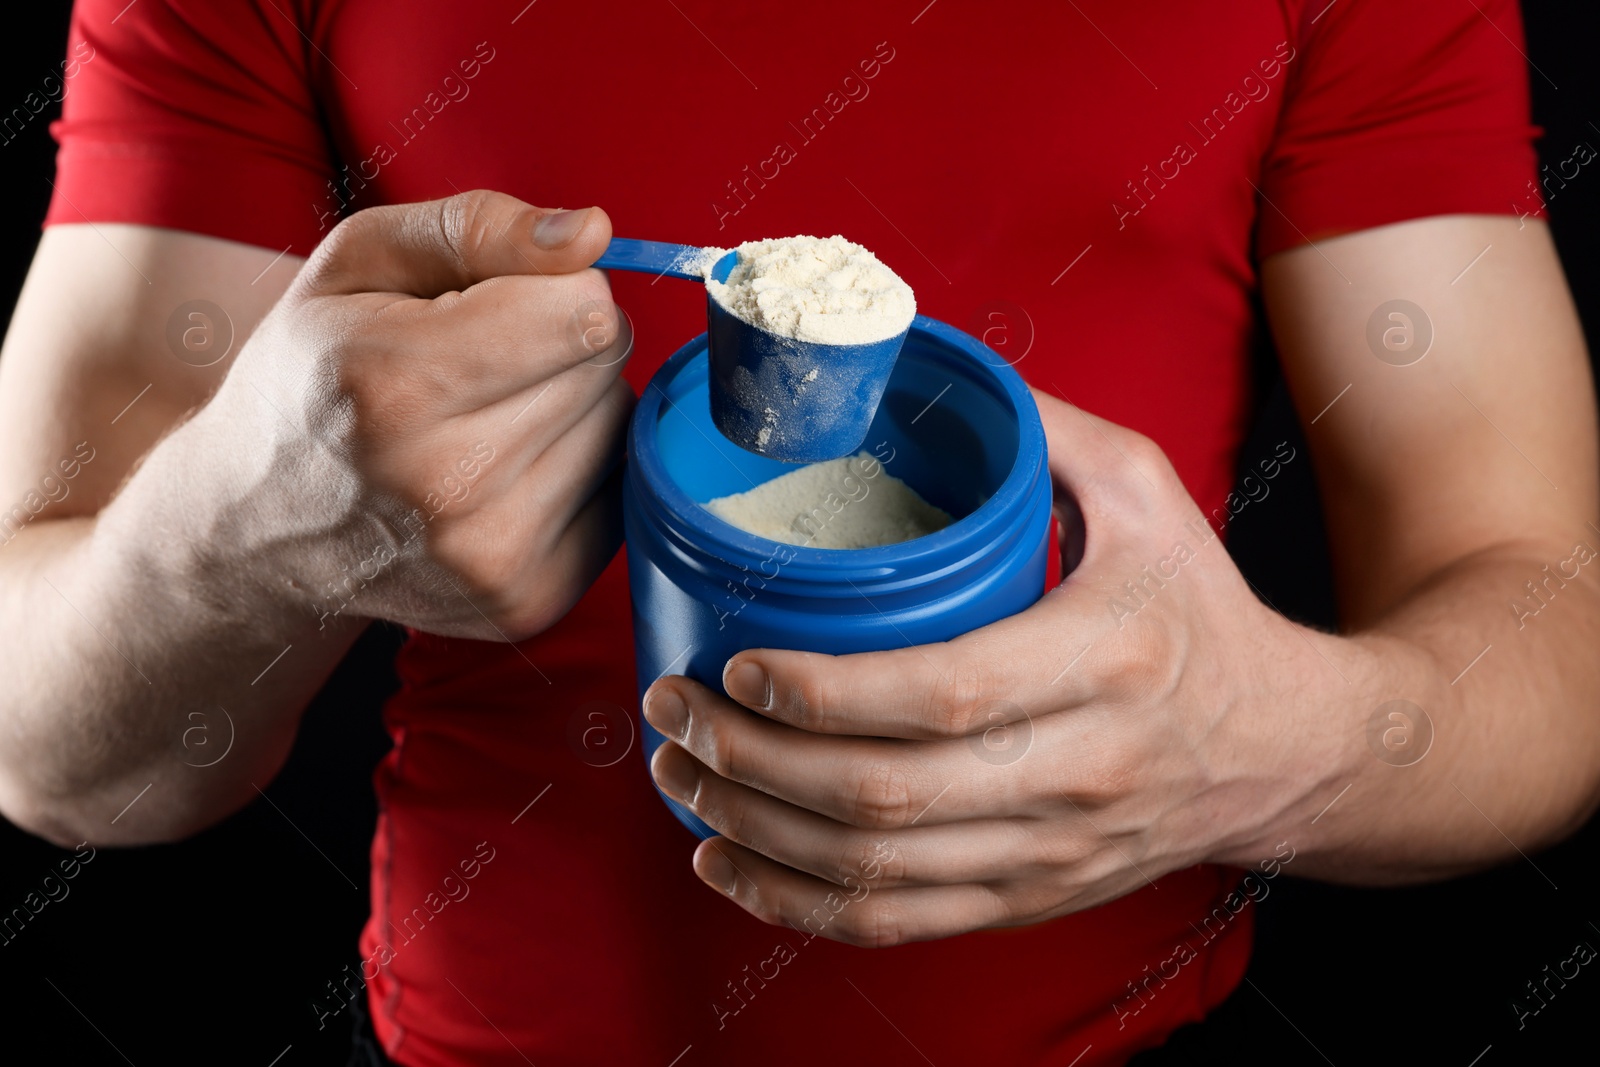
[706,453,954,549]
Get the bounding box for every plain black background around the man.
[0,0,1600,1067]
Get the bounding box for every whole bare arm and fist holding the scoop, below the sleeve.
[0,192,632,845]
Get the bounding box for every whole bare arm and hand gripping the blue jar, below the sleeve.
[645,216,1600,945]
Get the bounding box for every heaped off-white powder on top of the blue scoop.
[706,235,917,344]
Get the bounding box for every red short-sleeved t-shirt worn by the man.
[48,0,1538,1067]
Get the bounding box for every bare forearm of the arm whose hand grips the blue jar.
[1229,543,1600,885]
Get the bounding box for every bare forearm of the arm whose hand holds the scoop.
[0,396,362,843]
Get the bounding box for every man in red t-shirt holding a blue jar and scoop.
[0,0,1600,1065]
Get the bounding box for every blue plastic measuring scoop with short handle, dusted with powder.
[595,237,909,462]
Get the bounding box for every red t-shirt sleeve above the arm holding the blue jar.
[1256,0,1542,258]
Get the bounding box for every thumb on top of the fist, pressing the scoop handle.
[296,189,611,298]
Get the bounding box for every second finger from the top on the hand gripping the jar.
[645,675,1029,830]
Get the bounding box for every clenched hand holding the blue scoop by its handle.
[197,192,634,640]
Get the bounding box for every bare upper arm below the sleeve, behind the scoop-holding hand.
[0,224,304,521]
